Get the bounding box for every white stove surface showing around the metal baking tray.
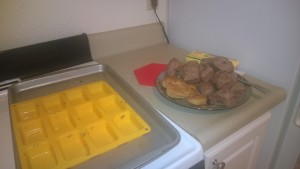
[0,90,204,169]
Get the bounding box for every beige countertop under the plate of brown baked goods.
[95,43,286,150]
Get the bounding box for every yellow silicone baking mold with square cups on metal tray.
[10,81,151,169]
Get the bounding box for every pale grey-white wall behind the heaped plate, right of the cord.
[168,0,300,169]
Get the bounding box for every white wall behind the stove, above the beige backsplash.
[0,0,167,51]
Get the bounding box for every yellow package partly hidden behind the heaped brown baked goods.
[185,50,240,69]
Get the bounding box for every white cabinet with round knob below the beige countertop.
[204,112,271,169]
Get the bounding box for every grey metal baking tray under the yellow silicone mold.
[8,64,180,169]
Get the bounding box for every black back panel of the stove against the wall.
[0,33,93,82]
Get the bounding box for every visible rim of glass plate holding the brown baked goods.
[156,72,252,110]
